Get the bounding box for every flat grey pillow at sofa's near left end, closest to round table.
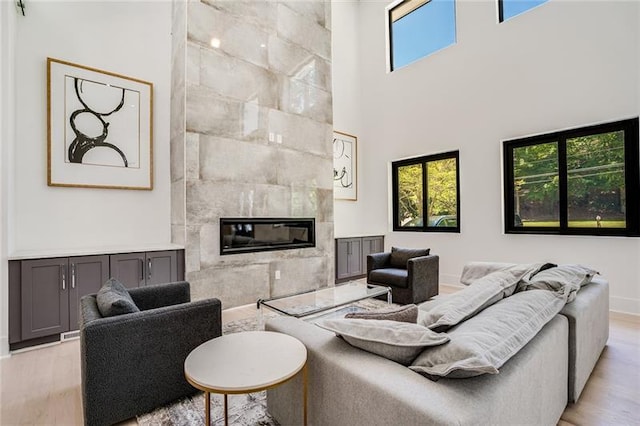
[316,319,449,365]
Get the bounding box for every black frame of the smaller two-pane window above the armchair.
[391,150,460,233]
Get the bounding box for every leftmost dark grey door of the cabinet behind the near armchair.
[21,257,69,340]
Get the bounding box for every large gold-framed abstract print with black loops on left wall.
[47,58,153,190]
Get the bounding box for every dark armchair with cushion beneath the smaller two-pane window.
[367,247,440,304]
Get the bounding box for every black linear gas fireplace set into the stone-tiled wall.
[220,218,316,254]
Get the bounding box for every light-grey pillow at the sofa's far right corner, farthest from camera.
[522,265,598,303]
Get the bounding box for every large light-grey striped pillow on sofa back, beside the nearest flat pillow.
[409,290,564,379]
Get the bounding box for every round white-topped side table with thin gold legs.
[184,331,307,426]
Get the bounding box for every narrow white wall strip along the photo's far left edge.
[0,2,16,357]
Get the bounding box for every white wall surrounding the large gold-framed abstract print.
[10,1,171,253]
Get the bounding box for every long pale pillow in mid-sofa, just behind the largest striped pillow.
[421,264,541,331]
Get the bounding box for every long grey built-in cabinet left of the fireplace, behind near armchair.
[9,250,184,350]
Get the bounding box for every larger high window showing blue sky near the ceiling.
[386,0,456,71]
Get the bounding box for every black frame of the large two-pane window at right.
[502,117,640,237]
